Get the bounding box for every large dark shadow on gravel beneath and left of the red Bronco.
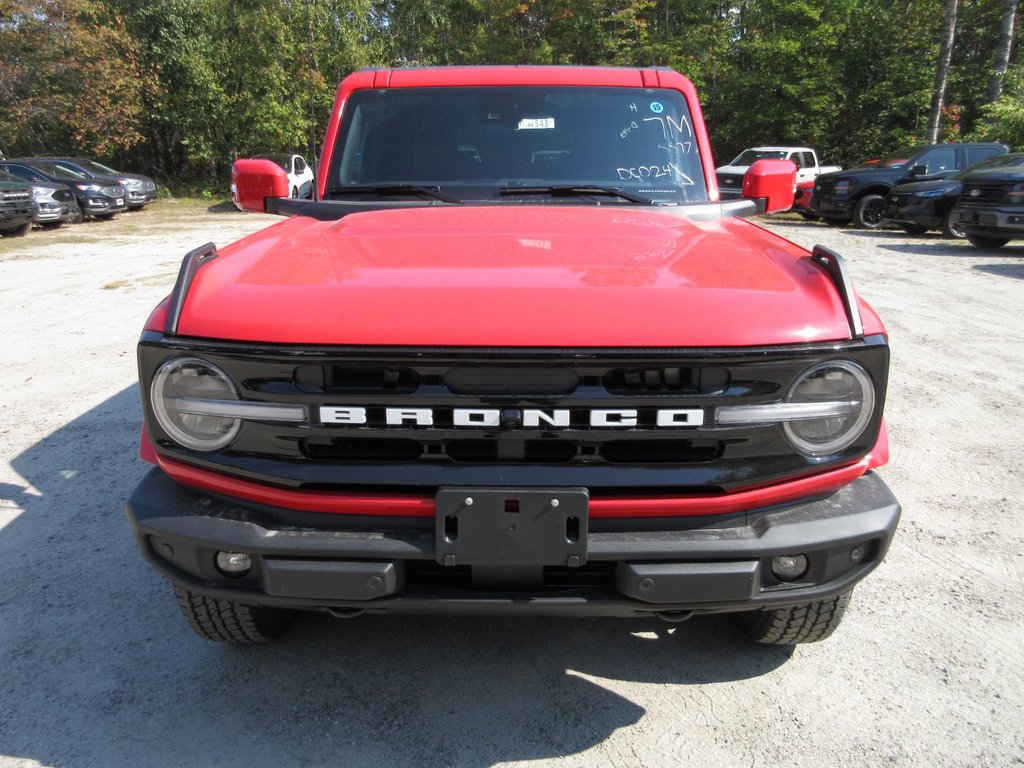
[0,388,792,768]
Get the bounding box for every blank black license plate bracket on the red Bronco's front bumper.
[434,487,590,567]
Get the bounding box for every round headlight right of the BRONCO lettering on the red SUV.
[782,360,874,458]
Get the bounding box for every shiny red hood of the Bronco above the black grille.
[178,206,882,347]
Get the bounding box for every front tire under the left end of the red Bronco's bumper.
[174,587,294,643]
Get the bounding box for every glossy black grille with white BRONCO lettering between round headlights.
[139,333,888,493]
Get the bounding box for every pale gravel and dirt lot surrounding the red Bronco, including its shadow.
[0,203,1024,768]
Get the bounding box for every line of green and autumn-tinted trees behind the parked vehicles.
[0,0,1024,184]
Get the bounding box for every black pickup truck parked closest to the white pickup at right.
[811,143,1009,229]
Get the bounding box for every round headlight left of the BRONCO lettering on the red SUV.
[150,357,242,452]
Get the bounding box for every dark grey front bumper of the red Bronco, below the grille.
[126,469,900,616]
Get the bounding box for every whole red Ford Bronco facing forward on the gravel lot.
[127,67,900,643]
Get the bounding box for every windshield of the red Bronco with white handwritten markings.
[327,86,708,204]
